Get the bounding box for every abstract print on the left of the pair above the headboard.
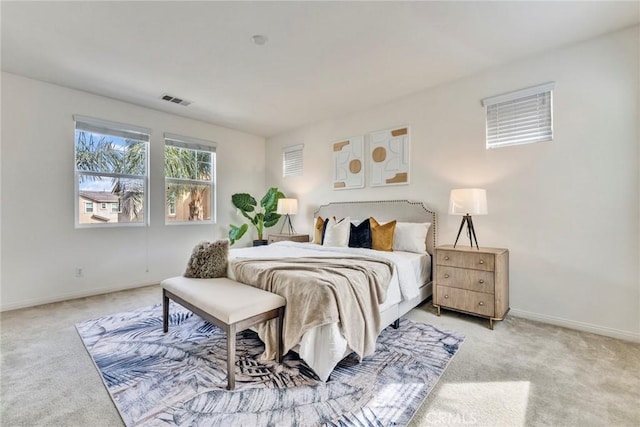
[333,135,364,190]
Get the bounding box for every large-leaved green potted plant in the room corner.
[229,187,285,246]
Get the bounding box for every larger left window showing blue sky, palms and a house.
[74,115,151,227]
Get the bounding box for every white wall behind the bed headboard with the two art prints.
[267,27,640,340]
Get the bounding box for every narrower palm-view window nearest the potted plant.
[164,133,216,223]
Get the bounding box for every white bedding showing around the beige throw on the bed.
[227,241,431,381]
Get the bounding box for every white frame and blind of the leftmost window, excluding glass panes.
[73,114,151,228]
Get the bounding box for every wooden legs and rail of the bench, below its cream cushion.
[162,288,284,390]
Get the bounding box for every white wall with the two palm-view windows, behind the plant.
[1,73,266,310]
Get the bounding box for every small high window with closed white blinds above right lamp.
[482,83,554,149]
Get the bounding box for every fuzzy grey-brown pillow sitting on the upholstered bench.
[184,239,229,279]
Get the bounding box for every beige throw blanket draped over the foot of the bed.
[230,257,393,359]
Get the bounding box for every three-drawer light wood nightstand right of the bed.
[433,245,509,329]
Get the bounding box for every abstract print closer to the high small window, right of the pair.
[369,126,410,187]
